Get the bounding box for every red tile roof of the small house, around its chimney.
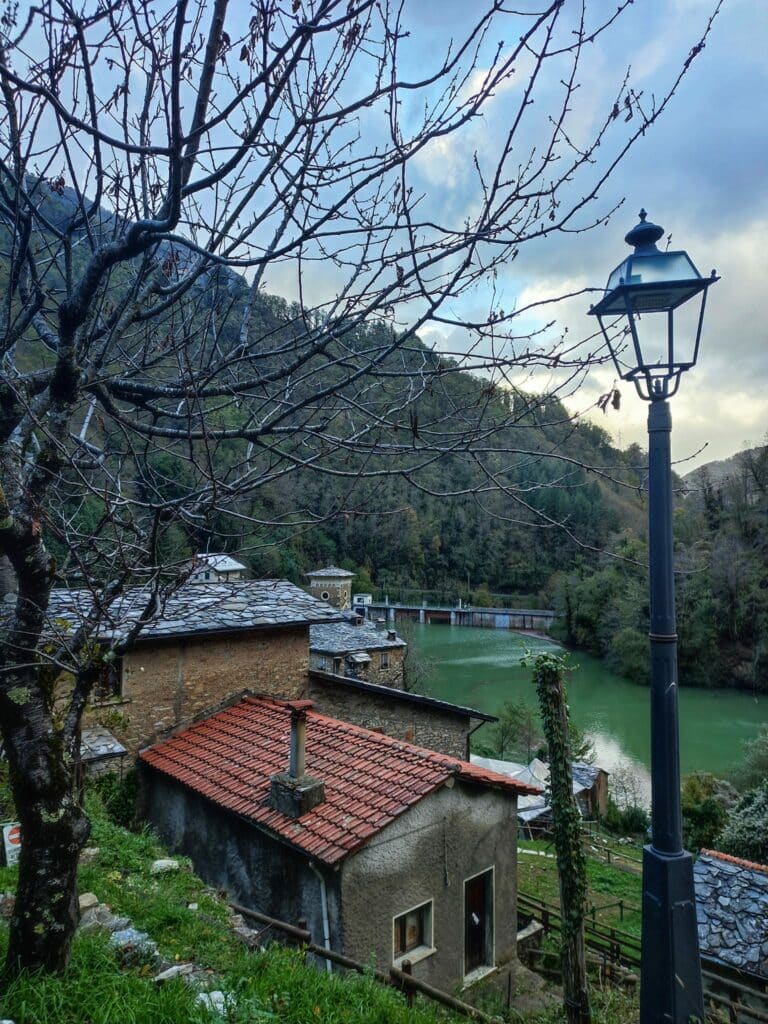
[139,696,539,864]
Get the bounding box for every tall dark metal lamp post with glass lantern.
[590,210,719,1024]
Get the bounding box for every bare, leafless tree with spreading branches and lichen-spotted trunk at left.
[0,0,720,970]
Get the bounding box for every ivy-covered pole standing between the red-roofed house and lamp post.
[534,654,592,1024]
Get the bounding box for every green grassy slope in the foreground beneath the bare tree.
[0,799,637,1024]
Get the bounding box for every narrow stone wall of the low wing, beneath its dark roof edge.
[309,676,470,760]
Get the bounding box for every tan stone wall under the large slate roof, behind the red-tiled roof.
[94,626,309,754]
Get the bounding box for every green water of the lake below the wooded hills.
[409,624,768,797]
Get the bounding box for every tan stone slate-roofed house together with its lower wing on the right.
[48,580,495,770]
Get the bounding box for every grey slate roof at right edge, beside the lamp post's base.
[693,850,768,978]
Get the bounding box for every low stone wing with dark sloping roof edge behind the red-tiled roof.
[308,671,498,761]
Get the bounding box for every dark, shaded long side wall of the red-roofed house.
[141,765,341,949]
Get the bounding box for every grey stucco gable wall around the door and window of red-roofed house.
[341,782,517,990]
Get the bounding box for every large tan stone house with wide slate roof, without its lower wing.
[48,580,338,755]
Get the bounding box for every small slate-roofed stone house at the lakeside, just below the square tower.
[309,615,408,689]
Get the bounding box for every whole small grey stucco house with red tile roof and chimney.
[140,697,530,989]
